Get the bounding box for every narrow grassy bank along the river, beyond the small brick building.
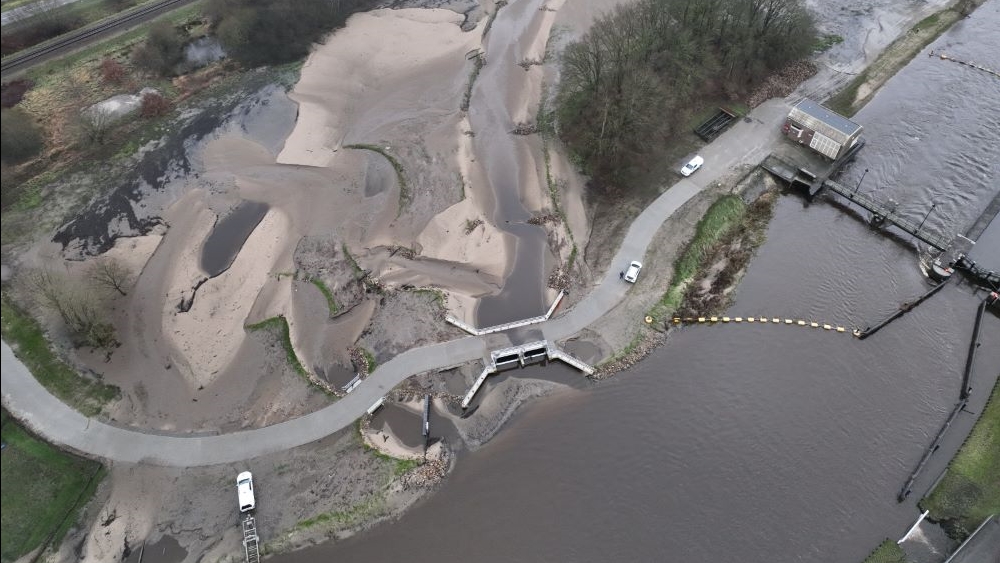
[825,0,984,117]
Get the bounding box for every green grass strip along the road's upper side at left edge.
[0,294,121,416]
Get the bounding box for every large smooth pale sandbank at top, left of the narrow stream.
[278,9,479,166]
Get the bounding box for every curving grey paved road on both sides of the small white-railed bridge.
[0,99,790,467]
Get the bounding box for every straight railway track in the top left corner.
[0,0,194,78]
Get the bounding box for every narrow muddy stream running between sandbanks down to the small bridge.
[469,0,548,326]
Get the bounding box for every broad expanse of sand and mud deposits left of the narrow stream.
[15,3,554,431]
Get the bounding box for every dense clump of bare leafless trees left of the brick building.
[556,0,816,191]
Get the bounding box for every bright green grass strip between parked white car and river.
[650,195,747,319]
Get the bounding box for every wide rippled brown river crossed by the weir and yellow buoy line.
[275,4,1000,563]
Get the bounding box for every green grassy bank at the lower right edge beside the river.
[920,381,1000,539]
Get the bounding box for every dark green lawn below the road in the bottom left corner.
[0,418,102,561]
